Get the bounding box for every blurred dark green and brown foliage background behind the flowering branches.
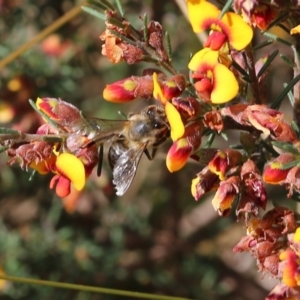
[0,0,289,300]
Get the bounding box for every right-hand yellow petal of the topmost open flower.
[221,12,253,51]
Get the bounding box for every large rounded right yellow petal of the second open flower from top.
[211,64,239,104]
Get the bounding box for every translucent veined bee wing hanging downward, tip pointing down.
[113,144,146,196]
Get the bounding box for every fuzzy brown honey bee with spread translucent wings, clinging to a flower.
[82,105,170,196]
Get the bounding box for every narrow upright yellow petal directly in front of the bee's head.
[165,102,184,141]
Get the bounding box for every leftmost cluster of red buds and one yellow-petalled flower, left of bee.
[7,98,98,202]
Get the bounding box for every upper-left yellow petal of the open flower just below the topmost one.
[188,48,219,71]
